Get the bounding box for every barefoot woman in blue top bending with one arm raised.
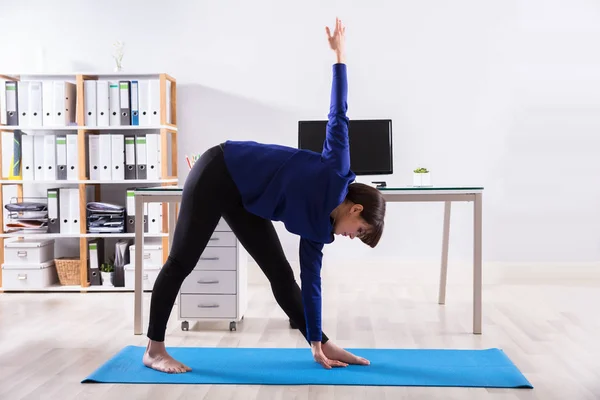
[143,19,385,373]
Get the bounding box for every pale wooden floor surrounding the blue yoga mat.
[0,267,600,400]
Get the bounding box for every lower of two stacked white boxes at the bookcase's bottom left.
[2,260,58,290]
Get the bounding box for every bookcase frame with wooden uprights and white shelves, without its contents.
[0,73,178,292]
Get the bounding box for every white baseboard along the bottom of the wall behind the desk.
[248,261,600,285]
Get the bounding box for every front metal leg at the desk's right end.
[473,193,483,334]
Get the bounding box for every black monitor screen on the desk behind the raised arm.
[298,119,393,175]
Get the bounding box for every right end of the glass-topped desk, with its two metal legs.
[382,186,483,334]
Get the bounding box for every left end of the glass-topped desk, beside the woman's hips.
[133,186,182,335]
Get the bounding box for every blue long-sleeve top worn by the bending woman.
[224,64,356,341]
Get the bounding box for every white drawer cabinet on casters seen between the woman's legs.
[178,219,248,331]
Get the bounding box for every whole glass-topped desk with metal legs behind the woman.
[134,186,483,335]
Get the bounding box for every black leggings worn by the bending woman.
[148,145,328,343]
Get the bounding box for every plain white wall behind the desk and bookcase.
[0,0,600,262]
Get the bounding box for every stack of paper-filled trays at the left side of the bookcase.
[4,202,48,233]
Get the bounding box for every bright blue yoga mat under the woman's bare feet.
[82,346,533,388]
